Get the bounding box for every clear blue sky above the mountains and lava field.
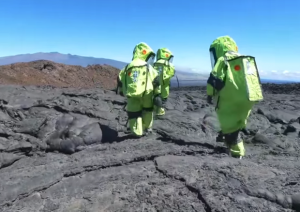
[0,0,300,78]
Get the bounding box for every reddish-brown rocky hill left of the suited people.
[0,60,120,89]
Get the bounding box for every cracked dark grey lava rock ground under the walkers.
[0,85,300,212]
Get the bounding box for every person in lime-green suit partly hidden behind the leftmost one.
[154,48,175,116]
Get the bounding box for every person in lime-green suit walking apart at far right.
[207,36,263,158]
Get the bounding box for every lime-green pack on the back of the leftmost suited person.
[124,64,150,97]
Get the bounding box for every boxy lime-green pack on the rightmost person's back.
[224,55,263,102]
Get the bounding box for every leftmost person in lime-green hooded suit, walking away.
[118,42,161,137]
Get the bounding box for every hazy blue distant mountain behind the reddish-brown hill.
[0,52,126,69]
